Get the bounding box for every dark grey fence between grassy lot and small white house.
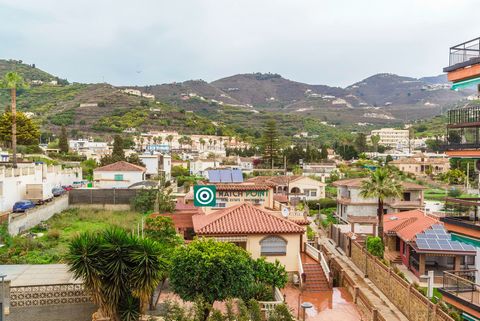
[68,188,139,205]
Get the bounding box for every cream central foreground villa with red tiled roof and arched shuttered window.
[192,203,306,272]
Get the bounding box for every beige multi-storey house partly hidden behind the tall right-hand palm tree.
[333,178,425,234]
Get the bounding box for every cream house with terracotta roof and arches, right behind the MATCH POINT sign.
[248,175,325,201]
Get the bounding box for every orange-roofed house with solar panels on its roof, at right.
[383,210,476,282]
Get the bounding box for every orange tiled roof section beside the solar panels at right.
[383,210,439,242]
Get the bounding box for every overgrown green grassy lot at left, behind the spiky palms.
[0,208,142,264]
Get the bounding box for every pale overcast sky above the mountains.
[0,0,480,87]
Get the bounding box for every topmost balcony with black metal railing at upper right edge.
[443,37,480,72]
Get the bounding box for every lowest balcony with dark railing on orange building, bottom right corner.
[439,270,480,316]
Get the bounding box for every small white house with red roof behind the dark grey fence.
[93,161,147,188]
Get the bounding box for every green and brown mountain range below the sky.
[0,60,472,139]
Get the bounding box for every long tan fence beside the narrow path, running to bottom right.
[351,241,453,321]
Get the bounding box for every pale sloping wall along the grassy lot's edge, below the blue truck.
[8,195,68,235]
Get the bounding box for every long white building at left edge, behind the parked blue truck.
[0,163,82,212]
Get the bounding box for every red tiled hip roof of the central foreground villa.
[193,203,305,235]
